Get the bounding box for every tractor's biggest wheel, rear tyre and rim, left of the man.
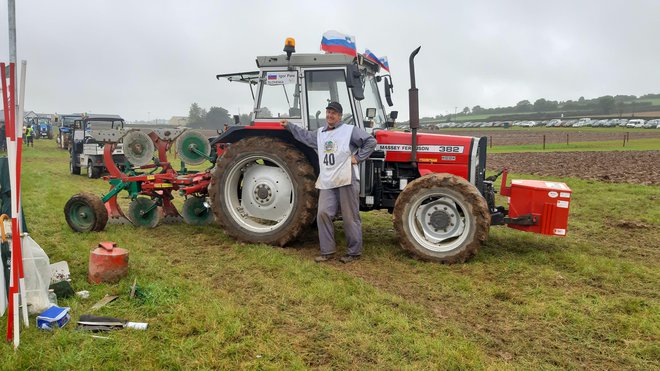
[209,137,318,246]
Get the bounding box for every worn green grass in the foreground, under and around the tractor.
[0,141,660,370]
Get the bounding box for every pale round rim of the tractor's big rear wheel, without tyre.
[221,155,296,233]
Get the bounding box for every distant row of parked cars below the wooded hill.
[420,117,660,130]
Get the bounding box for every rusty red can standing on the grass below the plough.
[87,242,128,283]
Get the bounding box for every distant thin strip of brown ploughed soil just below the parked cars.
[426,128,660,146]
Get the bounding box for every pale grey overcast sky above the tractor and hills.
[0,0,660,120]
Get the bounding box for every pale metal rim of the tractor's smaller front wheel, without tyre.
[407,191,473,252]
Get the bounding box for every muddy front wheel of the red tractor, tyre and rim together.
[394,174,490,263]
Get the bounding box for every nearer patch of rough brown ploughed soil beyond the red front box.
[486,151,660,185]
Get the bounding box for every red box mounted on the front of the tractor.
[502,180,572,236]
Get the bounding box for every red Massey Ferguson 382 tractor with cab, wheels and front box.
[68,39,571,263]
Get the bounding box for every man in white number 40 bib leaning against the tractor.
[280,102,376,263]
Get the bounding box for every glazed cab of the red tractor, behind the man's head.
[216,50,391,131]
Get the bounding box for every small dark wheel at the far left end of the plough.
[64,192,108,232]
